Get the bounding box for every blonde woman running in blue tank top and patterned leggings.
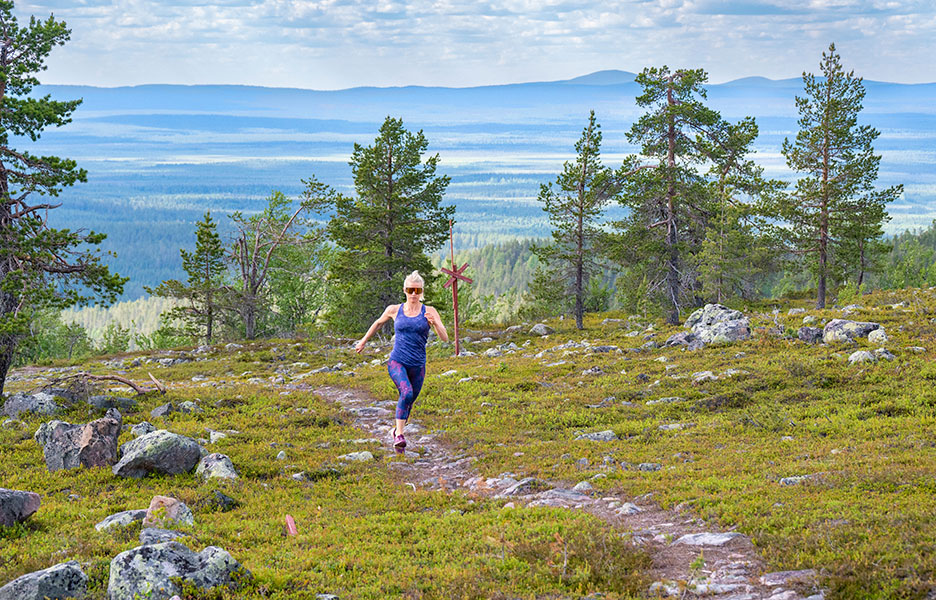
[354,271,448,448]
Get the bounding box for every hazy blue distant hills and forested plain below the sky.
[29,70,936,298]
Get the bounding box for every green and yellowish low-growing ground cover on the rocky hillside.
[0,290,936,599]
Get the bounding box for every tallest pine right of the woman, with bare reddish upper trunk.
[608,66,739,324]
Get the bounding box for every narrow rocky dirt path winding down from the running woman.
[313,386,822,600]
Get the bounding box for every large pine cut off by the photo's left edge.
[0,1,126,390]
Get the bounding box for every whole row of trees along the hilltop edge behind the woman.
[0,5,912,389]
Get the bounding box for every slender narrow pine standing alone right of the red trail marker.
[532,111,620,329]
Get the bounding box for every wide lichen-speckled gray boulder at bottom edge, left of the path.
[107,541,250,600]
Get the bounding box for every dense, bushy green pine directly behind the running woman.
[318,117,455,333]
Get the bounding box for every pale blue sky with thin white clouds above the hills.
[16,0,936,89]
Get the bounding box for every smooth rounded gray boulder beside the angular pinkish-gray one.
[112,429,201,478]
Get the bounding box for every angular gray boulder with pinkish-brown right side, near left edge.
[33,408,122,472]
